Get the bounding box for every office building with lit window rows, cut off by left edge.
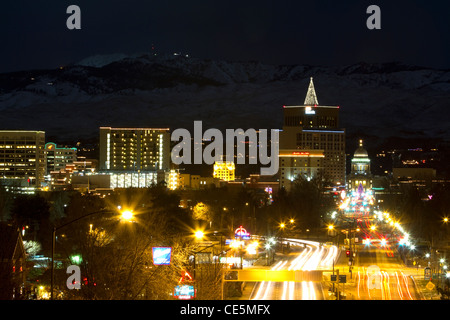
[0,130,46,188]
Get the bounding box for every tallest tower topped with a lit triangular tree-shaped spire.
[280,78,345,189]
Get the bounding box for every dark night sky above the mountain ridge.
[0,0,450,72]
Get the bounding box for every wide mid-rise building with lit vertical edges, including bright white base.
[99,127,171,189]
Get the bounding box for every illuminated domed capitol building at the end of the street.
[347,140,373,192]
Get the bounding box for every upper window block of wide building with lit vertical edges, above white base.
[99,127,170,172]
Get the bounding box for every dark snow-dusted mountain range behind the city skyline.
[0,53,450,146]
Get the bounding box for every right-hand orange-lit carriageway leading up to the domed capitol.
[342,192,419,300]
